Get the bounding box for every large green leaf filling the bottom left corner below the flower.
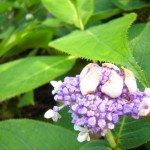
[0,119,83,150]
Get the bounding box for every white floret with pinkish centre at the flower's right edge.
[138,98,150,116]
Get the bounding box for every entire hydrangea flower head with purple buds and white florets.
[45,63,150,142]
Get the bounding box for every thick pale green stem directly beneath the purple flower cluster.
[106,130,117,149]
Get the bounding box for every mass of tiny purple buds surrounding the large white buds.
[49,65,146,136]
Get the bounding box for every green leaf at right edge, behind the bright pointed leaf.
[129,23,150,86]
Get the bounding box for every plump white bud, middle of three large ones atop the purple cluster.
[101,70,123,98]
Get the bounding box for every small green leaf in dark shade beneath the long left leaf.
[18,91,34,107]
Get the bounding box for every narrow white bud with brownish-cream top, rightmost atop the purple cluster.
[122,67,137,93]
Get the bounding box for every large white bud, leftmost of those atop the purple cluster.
[80,63,101,95]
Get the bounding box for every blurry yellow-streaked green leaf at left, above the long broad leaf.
[0,24,52,56]
